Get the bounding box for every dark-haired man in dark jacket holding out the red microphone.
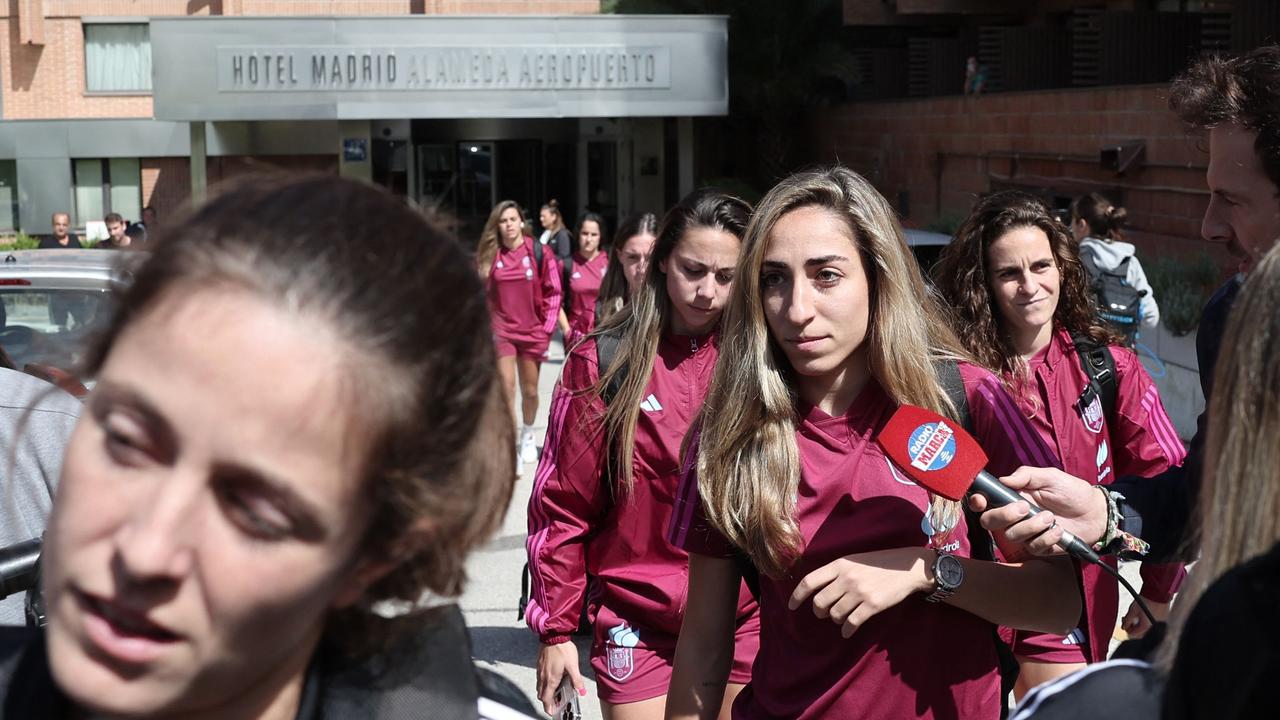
[978,45,1280,561]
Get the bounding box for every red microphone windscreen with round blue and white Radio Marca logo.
[876,405,987,500]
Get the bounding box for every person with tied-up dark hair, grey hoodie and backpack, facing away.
[1071,192,1160,328]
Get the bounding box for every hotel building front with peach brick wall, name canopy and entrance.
[0,0,728,239]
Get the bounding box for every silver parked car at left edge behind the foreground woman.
[0,250,142,397]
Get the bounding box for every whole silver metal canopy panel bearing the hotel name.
[151,15,728,120]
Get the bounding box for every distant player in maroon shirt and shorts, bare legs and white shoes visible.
[476,200,561,464]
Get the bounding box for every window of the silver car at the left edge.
[0,288,110,372]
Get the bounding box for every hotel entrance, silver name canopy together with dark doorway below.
[135,15,728,242]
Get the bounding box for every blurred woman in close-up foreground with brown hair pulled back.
[0,176,532,720]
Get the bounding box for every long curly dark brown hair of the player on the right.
[933,191,1123,378]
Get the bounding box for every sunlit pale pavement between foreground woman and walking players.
[462,340,600,720]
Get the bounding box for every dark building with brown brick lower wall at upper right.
[817,0,1280,270]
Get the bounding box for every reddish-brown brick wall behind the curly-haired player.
[817,86,1226,265]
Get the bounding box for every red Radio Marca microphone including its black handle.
[876,405,1100,564]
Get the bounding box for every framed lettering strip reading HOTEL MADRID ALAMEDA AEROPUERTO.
[218,45,671,92]
